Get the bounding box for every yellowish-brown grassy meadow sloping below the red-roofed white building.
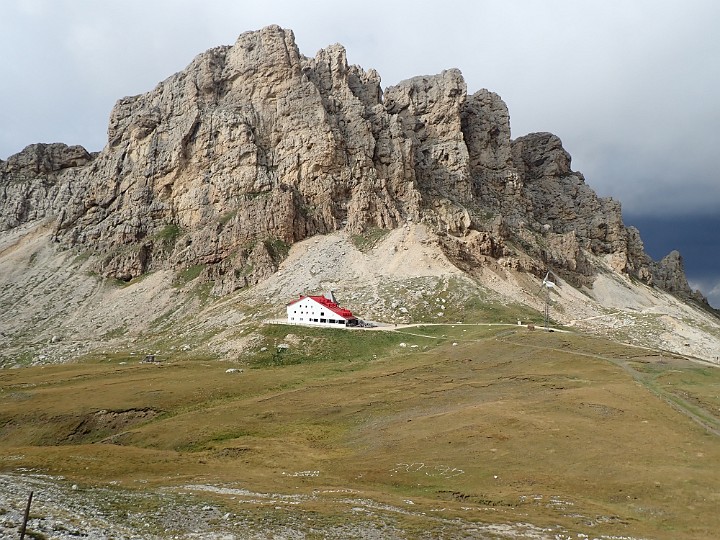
[0,324,720,539]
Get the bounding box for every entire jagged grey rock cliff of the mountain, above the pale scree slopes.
[0,26,690,300]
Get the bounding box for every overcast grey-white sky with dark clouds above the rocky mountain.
[0,0,720,305]
